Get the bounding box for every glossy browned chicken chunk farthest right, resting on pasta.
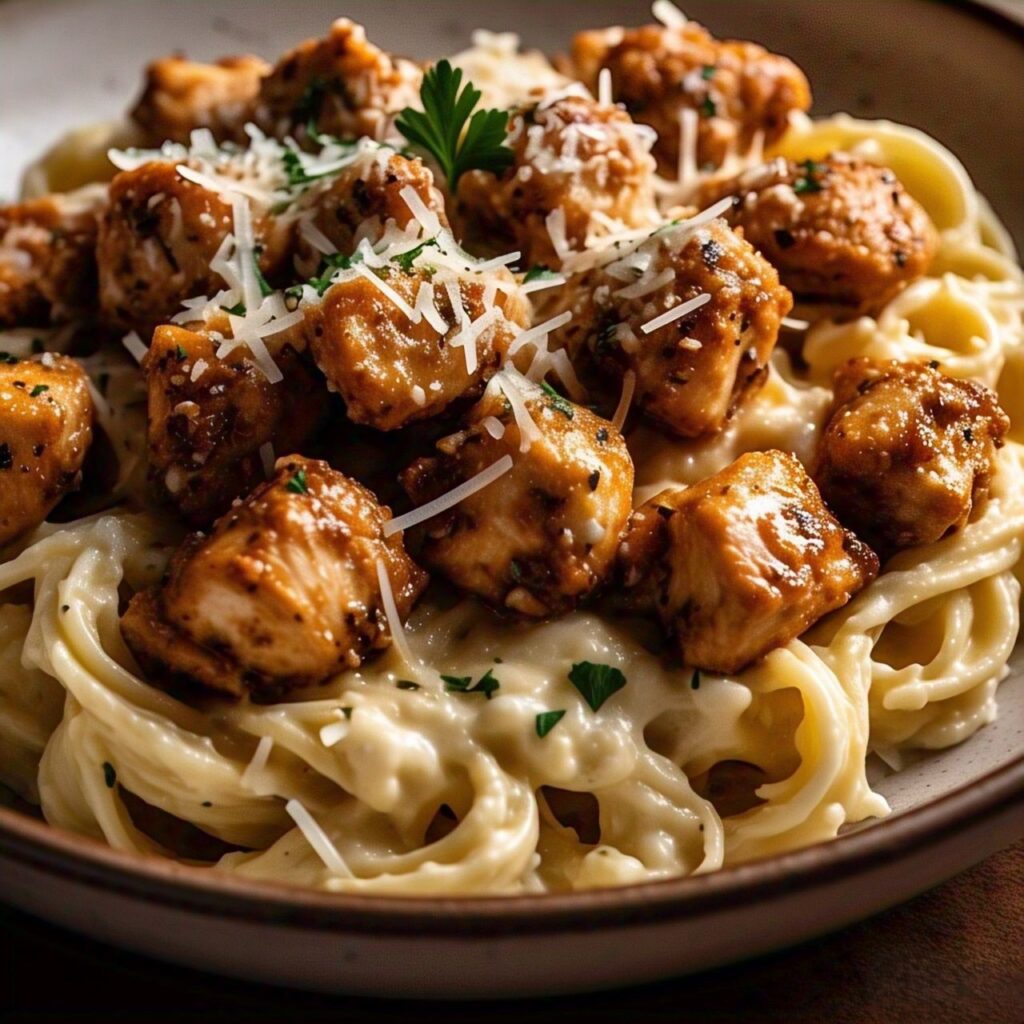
[813,358,1010,554]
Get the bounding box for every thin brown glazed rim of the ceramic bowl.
[0,0,1024,936]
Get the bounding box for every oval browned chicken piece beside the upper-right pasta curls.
[700,154,938,313]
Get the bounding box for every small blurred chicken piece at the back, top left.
[129,55,270,148]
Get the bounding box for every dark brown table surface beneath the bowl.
[0,842,1024,1024]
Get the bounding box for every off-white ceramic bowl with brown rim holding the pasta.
[0,0,1024,997]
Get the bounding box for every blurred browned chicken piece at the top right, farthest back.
[566,22,811,178]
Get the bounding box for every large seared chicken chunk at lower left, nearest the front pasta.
[121,456,426,696]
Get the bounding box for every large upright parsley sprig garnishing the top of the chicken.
[395,60,513,191]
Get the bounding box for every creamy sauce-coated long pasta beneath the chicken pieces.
[0,14,1024,895]
